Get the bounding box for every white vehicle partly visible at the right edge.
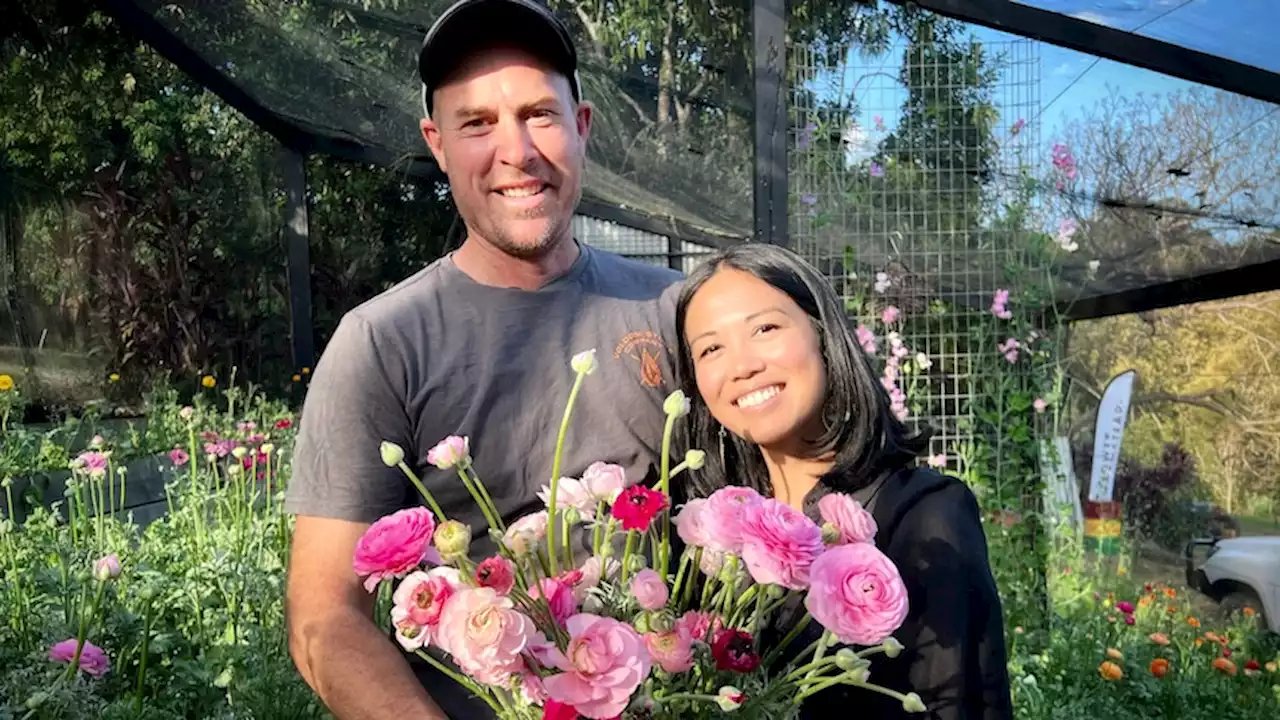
[1184,536,1280,633]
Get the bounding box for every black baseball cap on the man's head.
[417,0,582,115]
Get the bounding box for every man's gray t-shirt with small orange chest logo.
[284,245,682,720]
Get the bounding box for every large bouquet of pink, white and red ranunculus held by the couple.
[355,351,924,720]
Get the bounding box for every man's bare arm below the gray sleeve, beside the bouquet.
[285,515,448,720]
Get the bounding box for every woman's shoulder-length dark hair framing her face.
[676,242,929,498]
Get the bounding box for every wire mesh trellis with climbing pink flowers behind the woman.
[788,27,1052,518]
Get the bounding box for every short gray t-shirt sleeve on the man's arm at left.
[284,313,412,523]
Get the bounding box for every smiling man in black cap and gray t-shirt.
[285,0,680,720]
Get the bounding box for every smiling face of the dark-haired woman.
[684,268,827,448]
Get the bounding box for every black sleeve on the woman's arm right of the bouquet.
[872,482,1012,720]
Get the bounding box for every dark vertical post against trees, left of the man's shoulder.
[280,147,315,372]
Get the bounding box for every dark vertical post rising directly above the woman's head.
[751,0,787,245]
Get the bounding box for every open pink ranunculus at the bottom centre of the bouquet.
[543,612,653,720]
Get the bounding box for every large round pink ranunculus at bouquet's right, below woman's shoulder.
[804,542,908,646]
